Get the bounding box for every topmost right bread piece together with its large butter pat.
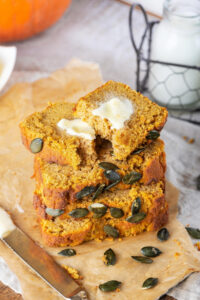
[74,81,168,160]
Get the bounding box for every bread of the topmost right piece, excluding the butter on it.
[74,81,168,160]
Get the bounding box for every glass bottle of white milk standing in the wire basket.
[148,0,200,108]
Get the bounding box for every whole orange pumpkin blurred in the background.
[0,0,71,42]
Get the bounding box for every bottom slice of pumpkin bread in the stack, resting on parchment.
[40,181,168,246]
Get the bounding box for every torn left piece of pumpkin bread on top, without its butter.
[20,103,96,168]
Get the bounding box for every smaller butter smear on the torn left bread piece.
[57,119,95,140]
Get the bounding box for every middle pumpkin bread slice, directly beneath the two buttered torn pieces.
[34,139,166,209]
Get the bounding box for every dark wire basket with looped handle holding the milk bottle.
[129,4,200,124]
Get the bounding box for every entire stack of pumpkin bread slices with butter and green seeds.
[20,81,168,246]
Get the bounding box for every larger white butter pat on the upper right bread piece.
[92,97,134,129]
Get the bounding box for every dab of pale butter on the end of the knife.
[0,207,16,239]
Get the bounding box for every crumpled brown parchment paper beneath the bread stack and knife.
[0,60,200,300]
